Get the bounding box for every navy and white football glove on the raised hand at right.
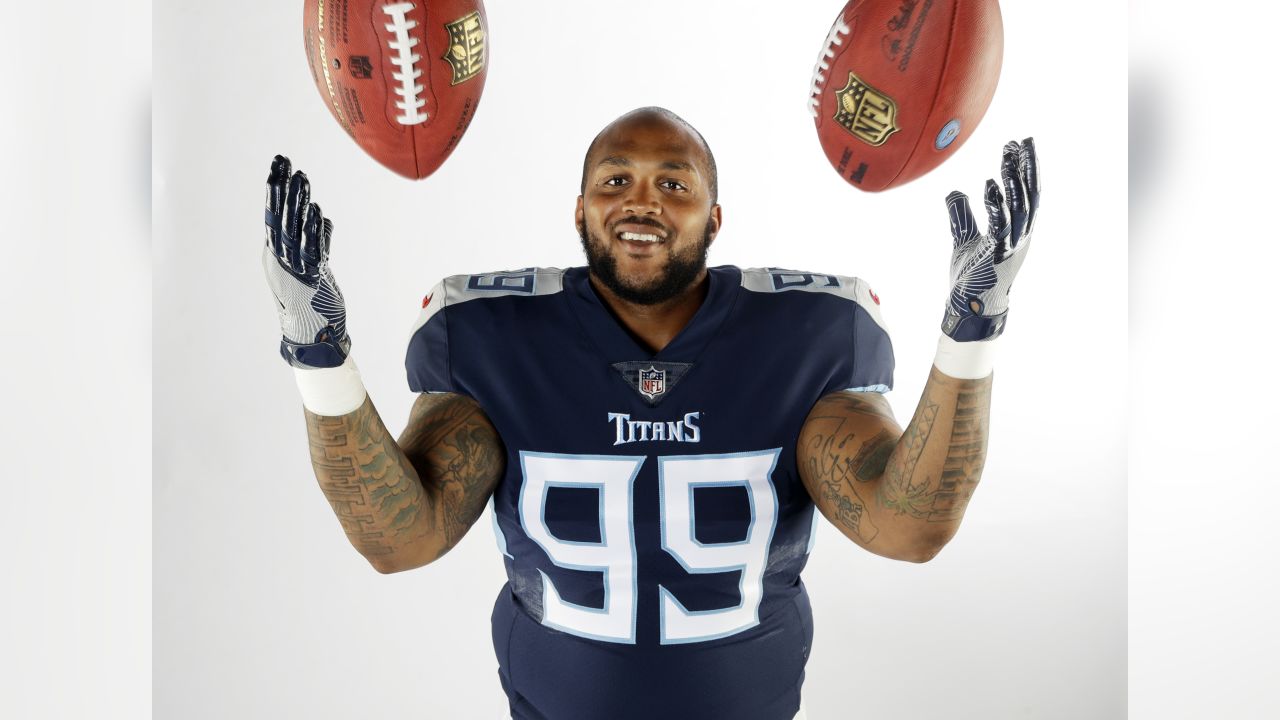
[942,137,1039,342]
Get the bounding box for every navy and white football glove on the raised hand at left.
[262,155,351,368]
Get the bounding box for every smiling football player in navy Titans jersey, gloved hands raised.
[262,108,1039,720]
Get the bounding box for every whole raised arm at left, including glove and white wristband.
[262,155,506,573]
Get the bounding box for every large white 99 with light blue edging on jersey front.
[520,448,781,644]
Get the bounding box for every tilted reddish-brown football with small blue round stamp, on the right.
[809,0,1005,192]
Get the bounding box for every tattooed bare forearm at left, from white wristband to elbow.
[306,398,433,557]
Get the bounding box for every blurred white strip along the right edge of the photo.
[1129,0,1280,720]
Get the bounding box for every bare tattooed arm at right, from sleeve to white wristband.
[797,368,991,562]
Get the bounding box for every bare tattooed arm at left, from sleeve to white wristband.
[306,393,506,573]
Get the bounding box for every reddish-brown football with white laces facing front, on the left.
[302,0,489,179]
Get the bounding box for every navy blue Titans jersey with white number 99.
[406,266,893,720]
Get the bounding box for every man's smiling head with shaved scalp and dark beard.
[576,117,721,305]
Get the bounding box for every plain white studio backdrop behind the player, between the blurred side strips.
[154,0,1126,720]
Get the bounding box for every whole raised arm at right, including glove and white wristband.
[796,137,1041,562]
